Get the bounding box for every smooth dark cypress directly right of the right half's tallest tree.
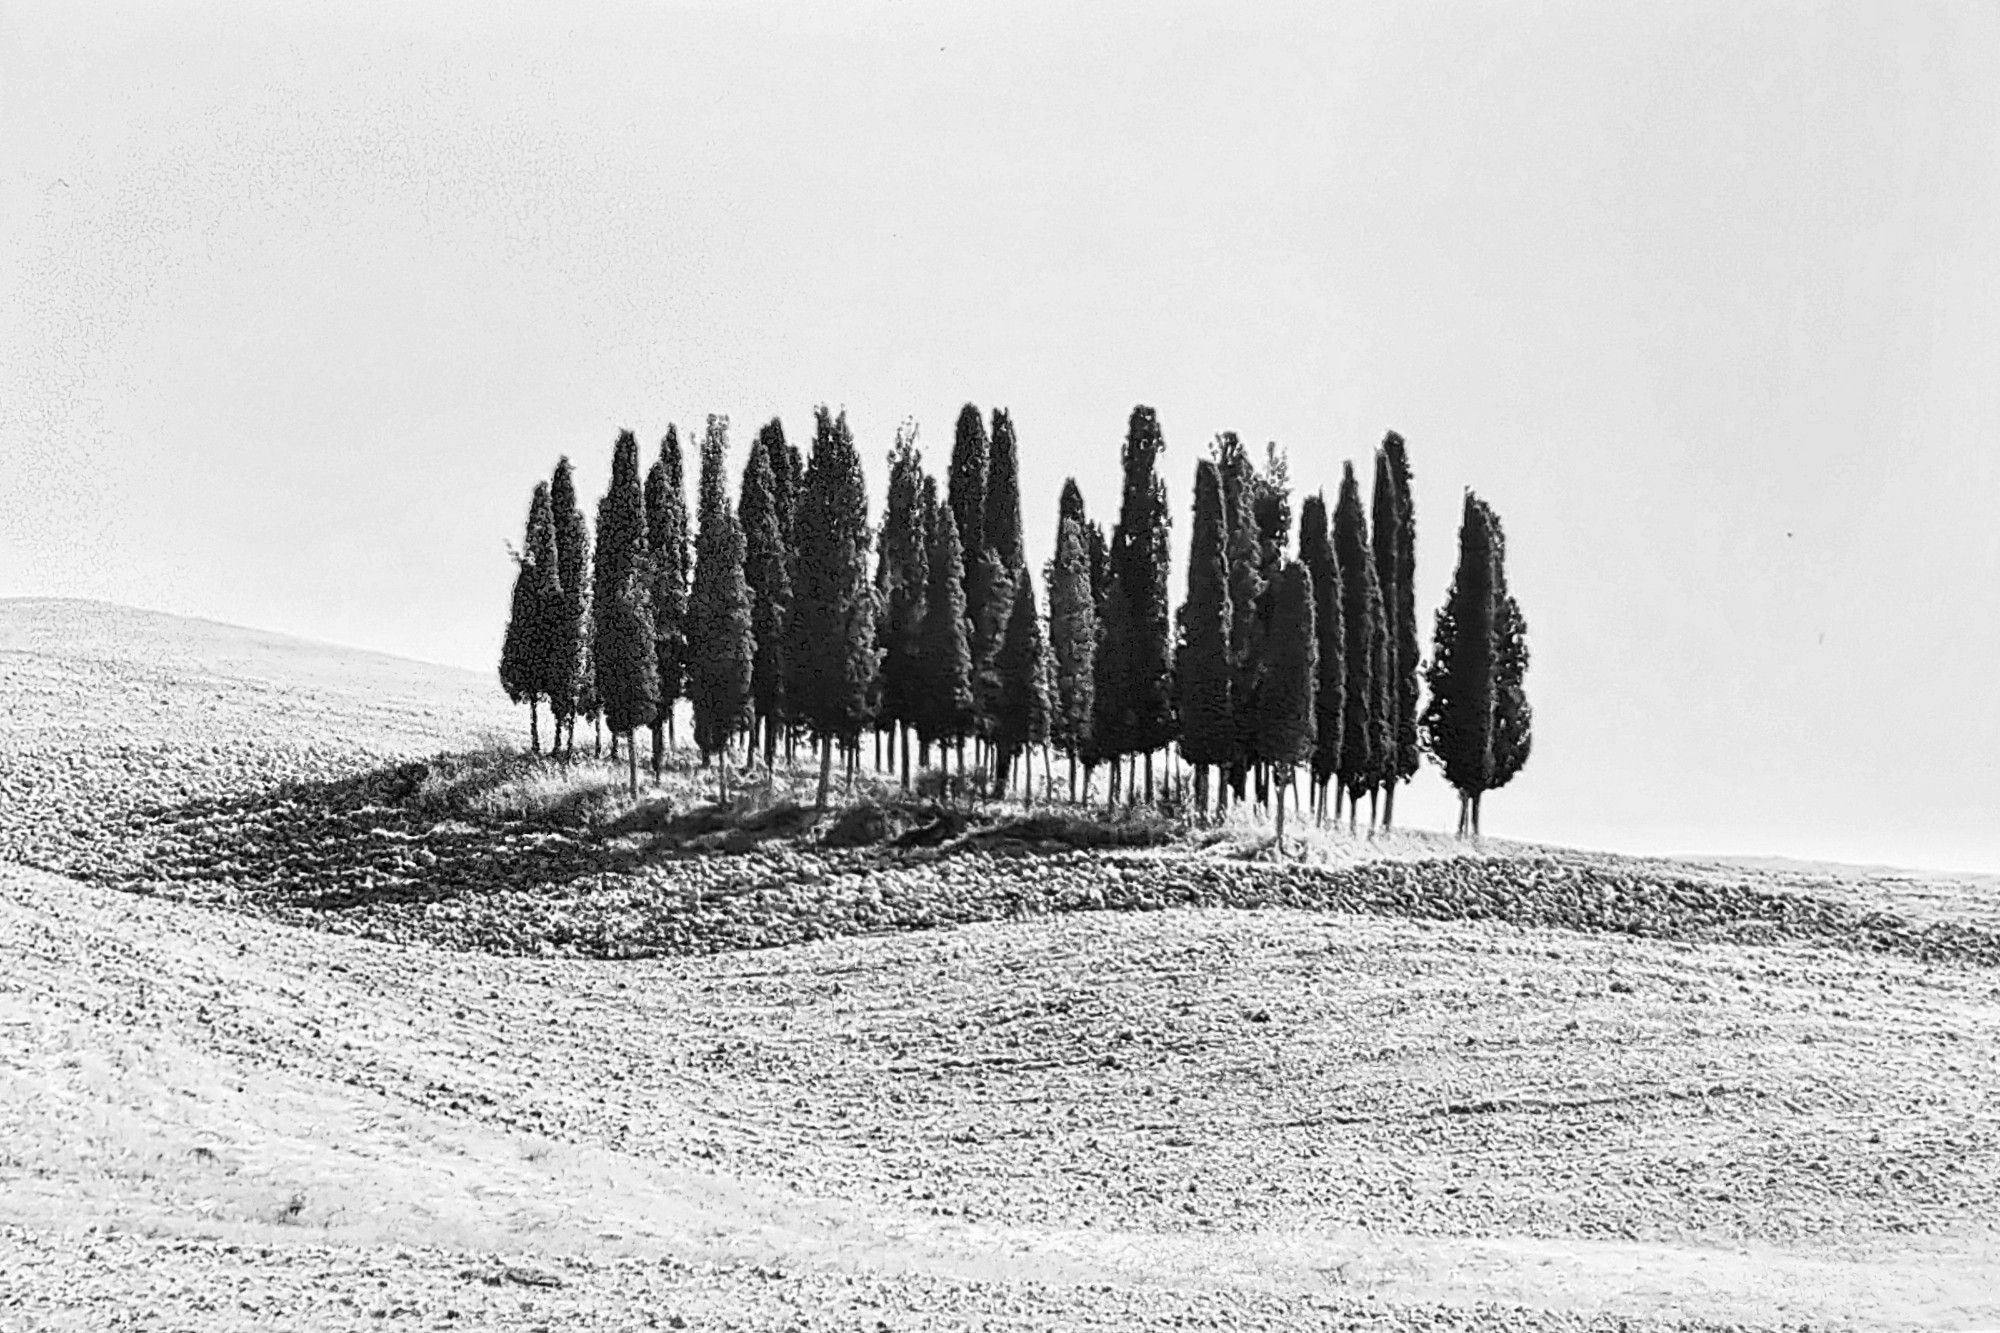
[1168,458,1240,815]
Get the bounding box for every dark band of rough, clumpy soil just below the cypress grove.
[11,755,2000,967]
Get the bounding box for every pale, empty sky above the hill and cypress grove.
[0,0,2000,871]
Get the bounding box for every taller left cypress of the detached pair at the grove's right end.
[1420,490,1498,835]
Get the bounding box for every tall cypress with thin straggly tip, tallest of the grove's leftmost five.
[688,414,756,801]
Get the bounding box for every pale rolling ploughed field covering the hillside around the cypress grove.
[0,604,2000,1329]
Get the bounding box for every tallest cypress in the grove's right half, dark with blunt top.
[1108,404,1174,799]
